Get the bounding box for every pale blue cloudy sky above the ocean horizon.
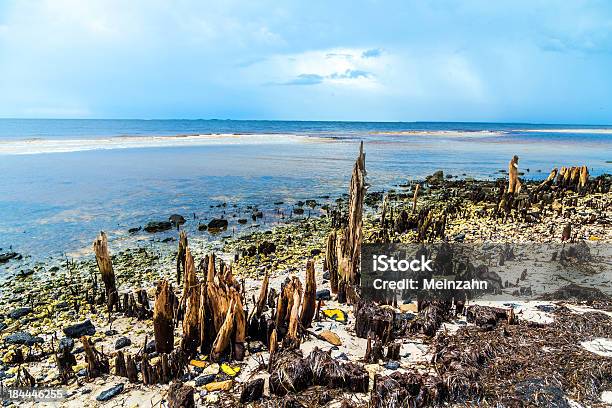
[0,0,612,124]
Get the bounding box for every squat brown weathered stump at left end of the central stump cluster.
[153,279,174,353]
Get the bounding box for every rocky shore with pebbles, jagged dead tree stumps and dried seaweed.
[0,145,612,407]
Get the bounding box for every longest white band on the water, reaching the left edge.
[0,134,313,155]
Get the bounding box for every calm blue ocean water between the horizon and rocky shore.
[0,119,612,264]
